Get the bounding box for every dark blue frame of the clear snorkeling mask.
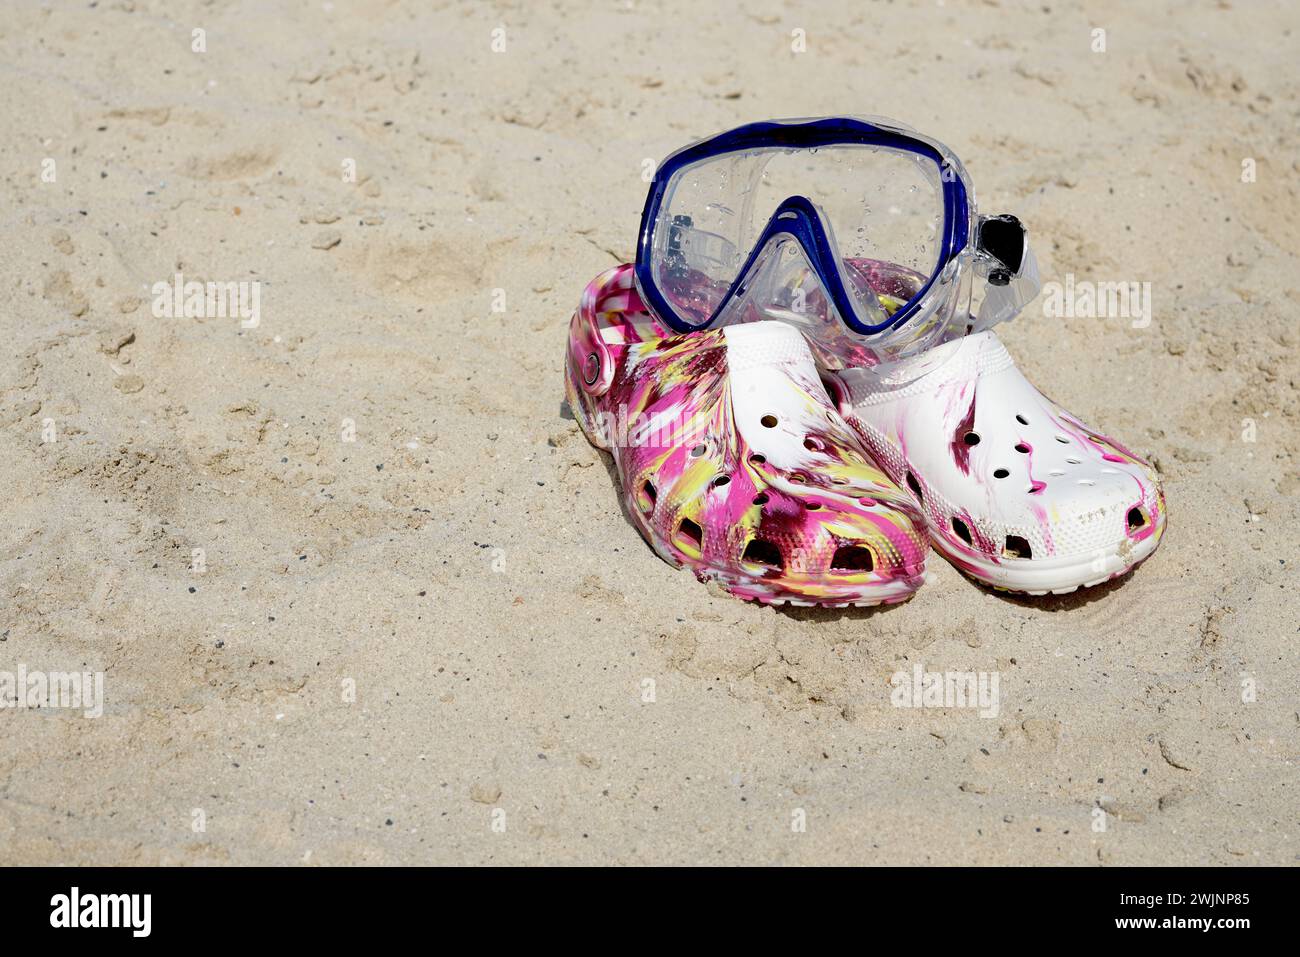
[636,117,970,335]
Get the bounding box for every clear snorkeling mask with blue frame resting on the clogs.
[636,117,1040,368]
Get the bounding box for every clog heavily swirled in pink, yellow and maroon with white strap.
[566,267,927,606]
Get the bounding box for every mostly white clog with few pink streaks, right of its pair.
[833,332,1165,594]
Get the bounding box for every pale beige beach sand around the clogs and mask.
[0,0,1300,865]
